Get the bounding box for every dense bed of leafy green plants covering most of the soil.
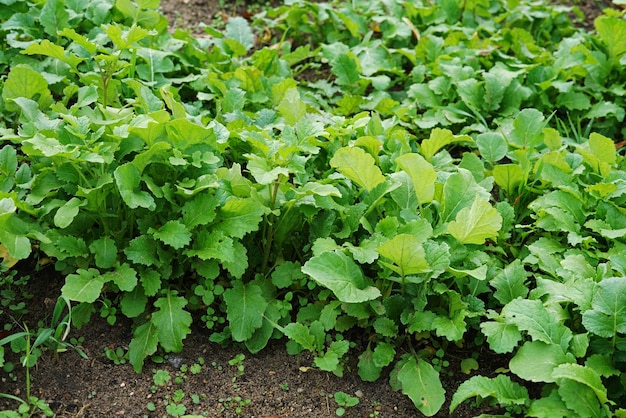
[0,0,626,417]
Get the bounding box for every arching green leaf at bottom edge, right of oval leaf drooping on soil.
[450,374,529,413]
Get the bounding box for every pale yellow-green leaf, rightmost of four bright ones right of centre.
[448,197,502,244]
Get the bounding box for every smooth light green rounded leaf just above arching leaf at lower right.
[509,341,574,383]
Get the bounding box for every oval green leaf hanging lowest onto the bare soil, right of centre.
[398,357,446,417]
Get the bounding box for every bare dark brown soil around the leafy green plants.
[0,0,610,418]
